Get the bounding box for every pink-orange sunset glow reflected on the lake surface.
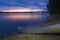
[4,13,42,20]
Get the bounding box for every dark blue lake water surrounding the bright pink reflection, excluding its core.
[0,13,50,36]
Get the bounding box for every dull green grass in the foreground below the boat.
[3,33,60,40]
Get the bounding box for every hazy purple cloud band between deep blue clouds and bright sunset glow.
[0,6,39,11]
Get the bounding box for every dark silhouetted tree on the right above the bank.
[47,0,60,19]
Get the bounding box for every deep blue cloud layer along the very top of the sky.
[0,0,46,6]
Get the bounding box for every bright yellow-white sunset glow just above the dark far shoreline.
[1,8,44,12]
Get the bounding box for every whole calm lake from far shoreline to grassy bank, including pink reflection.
[0,12,50,37]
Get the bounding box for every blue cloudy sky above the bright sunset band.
[0,0,48,10]
